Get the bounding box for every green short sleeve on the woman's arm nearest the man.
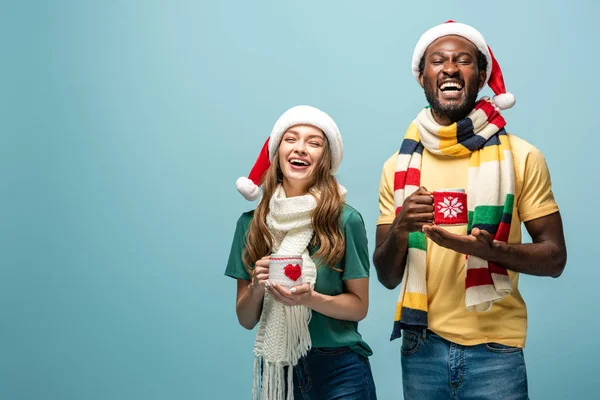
[342,209,370,280]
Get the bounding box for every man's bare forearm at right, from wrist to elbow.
[488,241,567,278]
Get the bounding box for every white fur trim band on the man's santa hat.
[412,22,492,83]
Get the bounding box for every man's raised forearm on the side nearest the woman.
[373,223,408,289]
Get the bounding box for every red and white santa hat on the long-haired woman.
[235,106,344,200]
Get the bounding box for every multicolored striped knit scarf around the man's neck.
[391,98,515,340]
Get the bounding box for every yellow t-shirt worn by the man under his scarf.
[377,135,558,347]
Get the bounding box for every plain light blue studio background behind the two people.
[0,0,600,400]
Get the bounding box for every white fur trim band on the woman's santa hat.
[269,106,344,174]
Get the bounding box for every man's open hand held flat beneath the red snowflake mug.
[423,225,494,260]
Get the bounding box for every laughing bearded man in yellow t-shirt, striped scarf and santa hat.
[373,21,566,400]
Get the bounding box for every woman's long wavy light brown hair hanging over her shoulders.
[243,138,345,270]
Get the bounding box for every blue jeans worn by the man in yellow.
[401,330,528,400]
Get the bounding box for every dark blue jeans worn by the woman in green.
[294,347,377,400]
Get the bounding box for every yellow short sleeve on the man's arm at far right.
[517,148,558,222]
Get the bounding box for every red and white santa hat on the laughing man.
[412,20,515,110]
